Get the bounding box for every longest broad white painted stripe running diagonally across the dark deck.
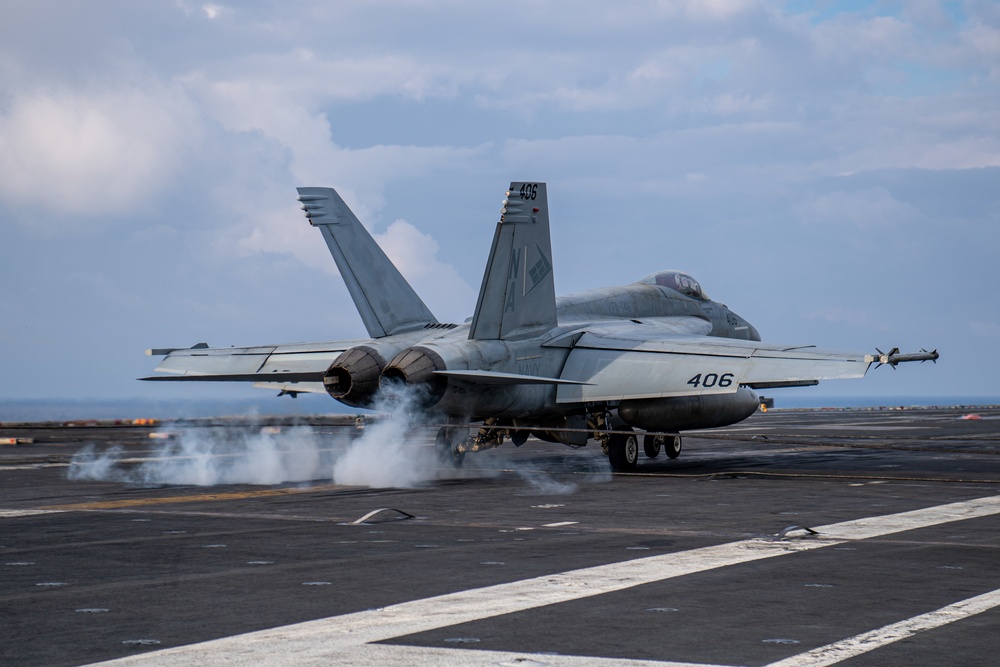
[84,496,1000,667]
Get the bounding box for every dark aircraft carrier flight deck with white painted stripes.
[0,407,1000,667]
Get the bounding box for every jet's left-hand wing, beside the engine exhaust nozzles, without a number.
[139,339,367,383]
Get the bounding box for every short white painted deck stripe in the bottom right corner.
[767,590,1000,667]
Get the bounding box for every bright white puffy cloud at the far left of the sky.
[0,86,200,222]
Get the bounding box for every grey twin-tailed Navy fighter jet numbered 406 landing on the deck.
[141,182,938,471]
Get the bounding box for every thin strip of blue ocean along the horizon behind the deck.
[0,392,1000,422]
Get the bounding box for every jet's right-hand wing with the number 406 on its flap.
[556,322,876,403]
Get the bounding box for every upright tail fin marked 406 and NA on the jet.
[469,182,556,340]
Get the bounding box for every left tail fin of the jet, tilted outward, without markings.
[297,188,437,338]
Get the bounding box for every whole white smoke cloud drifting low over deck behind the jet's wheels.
[68,387,611,495]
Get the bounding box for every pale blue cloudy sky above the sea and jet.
[0,0,1000,404]
